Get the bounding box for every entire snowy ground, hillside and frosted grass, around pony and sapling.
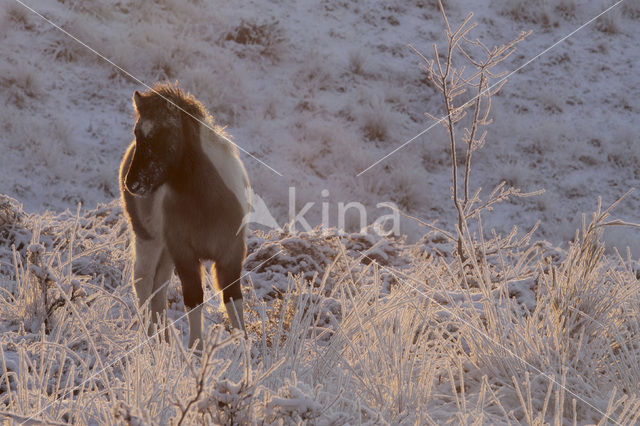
[0,0,640,424]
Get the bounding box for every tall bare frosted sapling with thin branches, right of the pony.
[410,1,533,259]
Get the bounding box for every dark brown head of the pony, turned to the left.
[124,89,184,196]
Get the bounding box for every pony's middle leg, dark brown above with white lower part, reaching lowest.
[175,256,204,351]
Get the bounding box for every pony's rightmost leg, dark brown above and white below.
[215,258,246,333]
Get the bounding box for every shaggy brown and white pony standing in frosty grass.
[119,82,251,350]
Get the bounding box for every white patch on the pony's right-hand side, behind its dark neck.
[200,121,251,220]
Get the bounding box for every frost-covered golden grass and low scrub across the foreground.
[0,197,640,424]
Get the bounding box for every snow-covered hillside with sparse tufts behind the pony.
[0,0,640,246]
